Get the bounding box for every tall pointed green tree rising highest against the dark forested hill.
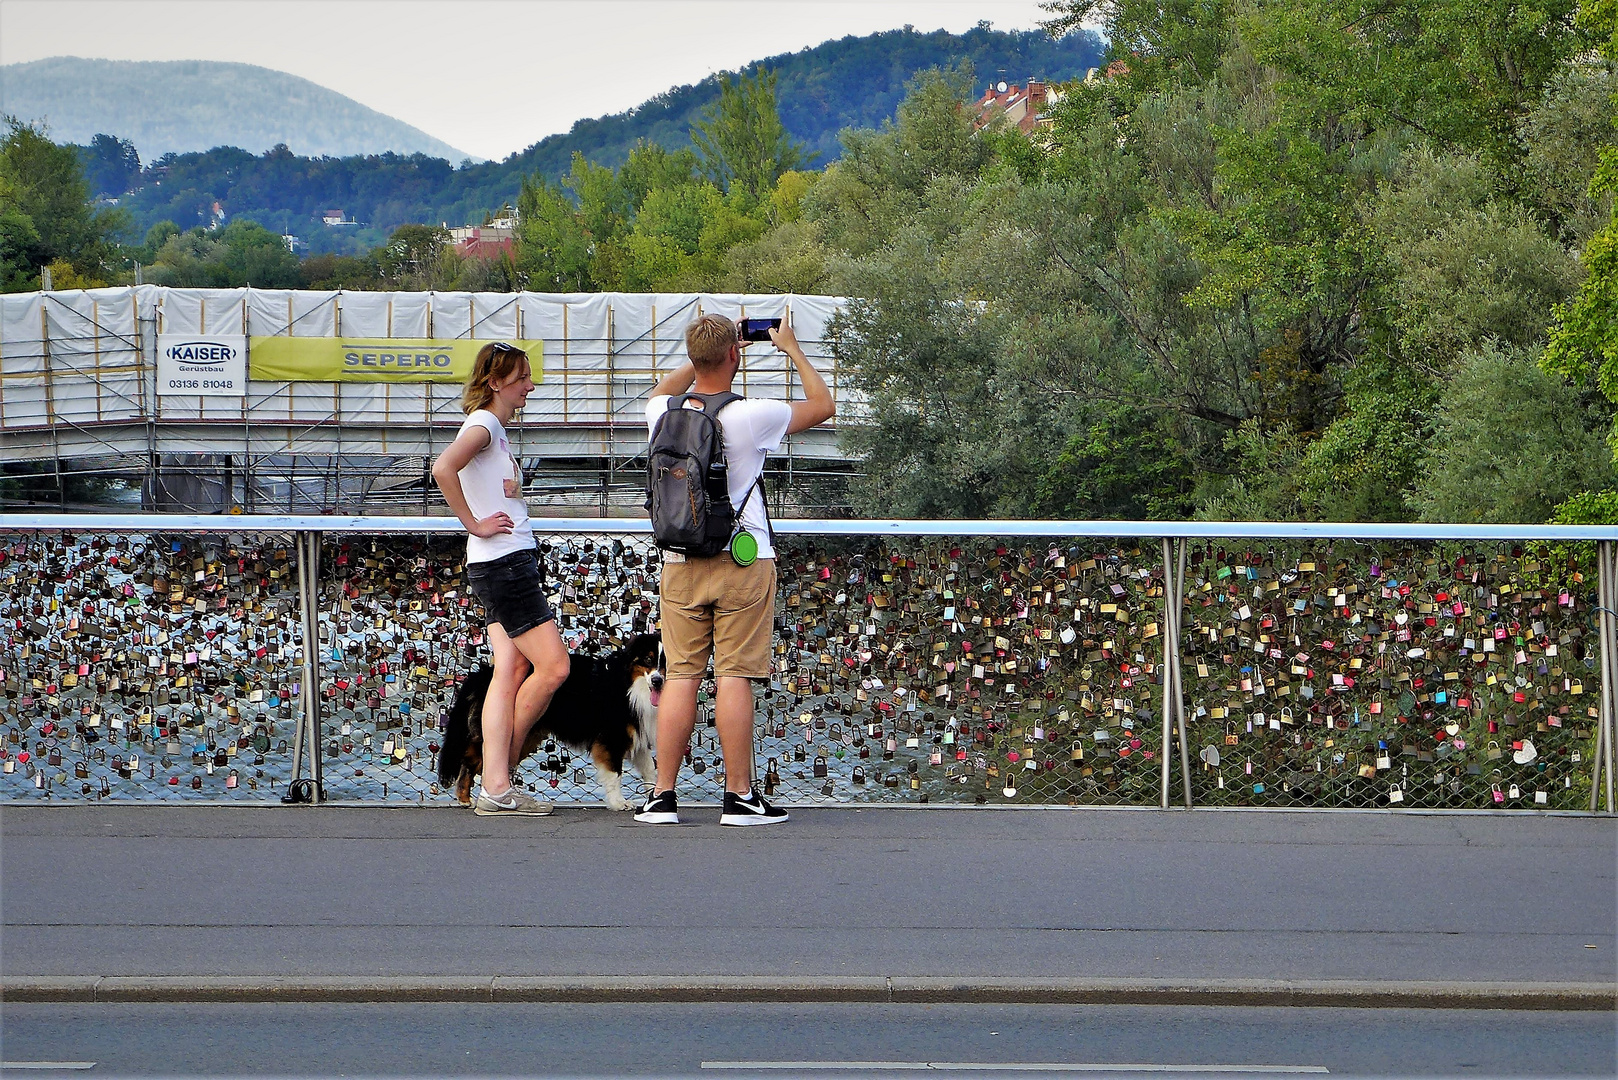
[691,68,803,199]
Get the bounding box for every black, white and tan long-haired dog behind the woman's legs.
[438,633,663,810]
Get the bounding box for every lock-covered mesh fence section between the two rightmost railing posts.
[1184,542,1600,810]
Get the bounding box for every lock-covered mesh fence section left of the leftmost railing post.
[0,533,303,800]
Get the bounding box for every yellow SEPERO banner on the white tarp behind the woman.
[248,337,544,384]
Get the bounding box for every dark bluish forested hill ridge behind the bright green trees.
[105,24,1102,248]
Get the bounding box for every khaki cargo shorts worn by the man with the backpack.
[659,552,775,678]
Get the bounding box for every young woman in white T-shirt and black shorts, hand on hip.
[432,342,568,814]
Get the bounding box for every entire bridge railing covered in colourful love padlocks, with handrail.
[0,513,1618,811]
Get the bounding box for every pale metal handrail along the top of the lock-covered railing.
[9,513,1618,541]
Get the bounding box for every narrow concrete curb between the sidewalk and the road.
[0,975,1618,1012]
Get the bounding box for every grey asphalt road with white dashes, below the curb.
[0,1004,1618,1078]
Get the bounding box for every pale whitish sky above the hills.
[0,0,1047,159]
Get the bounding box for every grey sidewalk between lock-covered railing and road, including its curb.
[0,806,1618,1007]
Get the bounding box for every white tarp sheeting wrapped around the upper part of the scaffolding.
[0,285,859,452]
